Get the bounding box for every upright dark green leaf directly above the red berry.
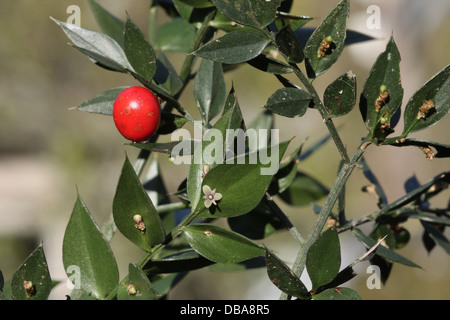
[124,17,156,80]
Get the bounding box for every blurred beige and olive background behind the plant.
[0,0,450,299]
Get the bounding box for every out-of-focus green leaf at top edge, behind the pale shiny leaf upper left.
[89,0,125,46]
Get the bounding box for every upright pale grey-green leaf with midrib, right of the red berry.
[194,59,227,125]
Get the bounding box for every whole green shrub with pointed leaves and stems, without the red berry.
[0,0,450,300]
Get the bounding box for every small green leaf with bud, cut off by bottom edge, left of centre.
[117,263,159,300]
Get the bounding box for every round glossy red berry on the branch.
[113,87,161,142]
